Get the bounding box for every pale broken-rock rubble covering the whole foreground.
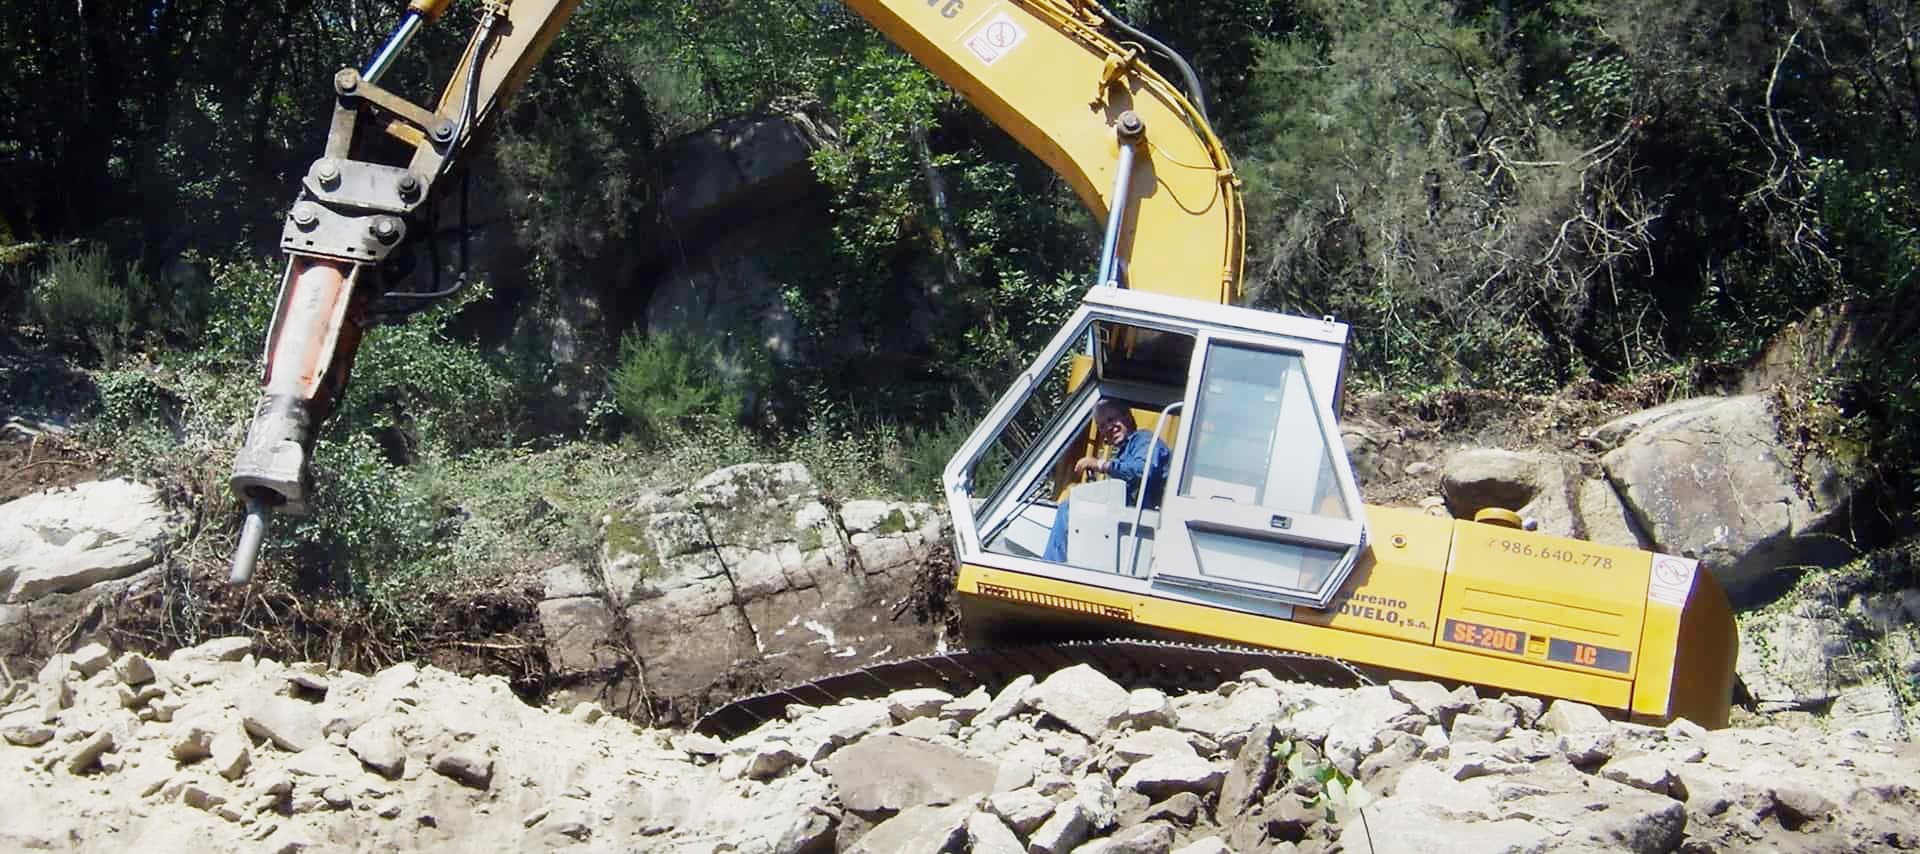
[0,637,1920,854]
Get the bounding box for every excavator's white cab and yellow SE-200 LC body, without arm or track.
[945,288,1736,725]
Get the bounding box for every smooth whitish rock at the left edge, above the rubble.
[0,478,169,603]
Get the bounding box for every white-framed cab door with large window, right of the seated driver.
[1154,330,1367,608]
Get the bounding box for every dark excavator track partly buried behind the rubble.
[693,639,1375,739]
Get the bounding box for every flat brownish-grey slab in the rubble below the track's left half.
[824,735,995,819]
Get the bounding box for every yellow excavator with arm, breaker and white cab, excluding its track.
[232,0,1736,727]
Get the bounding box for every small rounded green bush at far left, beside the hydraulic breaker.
[29,246,132,359]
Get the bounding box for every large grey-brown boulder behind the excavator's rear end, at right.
[1599,395,1855,603]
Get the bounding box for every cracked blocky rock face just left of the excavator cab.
[540,463,947,716]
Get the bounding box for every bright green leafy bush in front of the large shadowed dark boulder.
[612,332,745,441]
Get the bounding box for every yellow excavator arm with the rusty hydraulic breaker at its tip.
[230,0,1244,581]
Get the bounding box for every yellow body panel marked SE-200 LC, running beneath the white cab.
[958,507,1734,727]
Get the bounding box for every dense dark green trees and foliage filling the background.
[0,0,1920,587]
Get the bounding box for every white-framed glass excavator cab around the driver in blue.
[947,288,1367,616]
